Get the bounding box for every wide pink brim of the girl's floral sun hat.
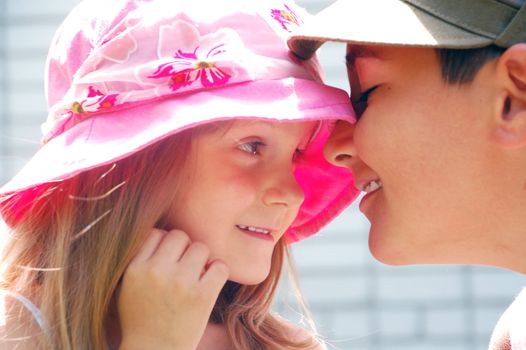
[0,78,358,241]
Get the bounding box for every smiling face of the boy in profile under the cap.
[326,46,502,264]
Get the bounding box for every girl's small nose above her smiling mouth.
[263,168,305,209]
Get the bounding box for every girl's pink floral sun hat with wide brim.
[0,0,357,241]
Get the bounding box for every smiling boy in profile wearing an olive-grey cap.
[289,0,526,350]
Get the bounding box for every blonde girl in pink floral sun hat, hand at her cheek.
[0,0,356,350]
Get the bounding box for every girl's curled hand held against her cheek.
[117,229,228,350]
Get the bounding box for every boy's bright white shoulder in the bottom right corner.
[489,288,526,350]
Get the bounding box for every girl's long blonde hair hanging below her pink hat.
[0,128,318,350]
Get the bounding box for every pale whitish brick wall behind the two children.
[0,0,524,350]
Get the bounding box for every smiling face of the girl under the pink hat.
[171,121,317,284]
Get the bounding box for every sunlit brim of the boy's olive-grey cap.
[288,0,493,59]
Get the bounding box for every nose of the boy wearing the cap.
[324,120,358,169]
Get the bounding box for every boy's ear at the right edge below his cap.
[494,44,526,148]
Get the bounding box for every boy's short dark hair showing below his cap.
[436,45,506,85]
